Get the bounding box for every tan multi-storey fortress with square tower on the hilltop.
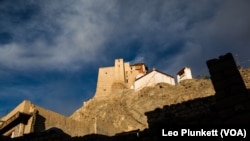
[95,59,148,97]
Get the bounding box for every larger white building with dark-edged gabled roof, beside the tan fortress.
[134,69,175,90]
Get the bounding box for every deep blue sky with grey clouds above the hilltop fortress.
[0,0,250,117]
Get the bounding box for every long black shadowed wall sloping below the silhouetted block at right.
[146,91,250,129]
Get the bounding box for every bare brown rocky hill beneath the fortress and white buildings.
[70,68,250,135]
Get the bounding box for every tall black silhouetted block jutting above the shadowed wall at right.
[206,53,247,95]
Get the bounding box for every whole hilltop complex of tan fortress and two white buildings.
[95,59,192,97]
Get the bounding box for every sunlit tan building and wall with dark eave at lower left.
[0,100,89,137]
